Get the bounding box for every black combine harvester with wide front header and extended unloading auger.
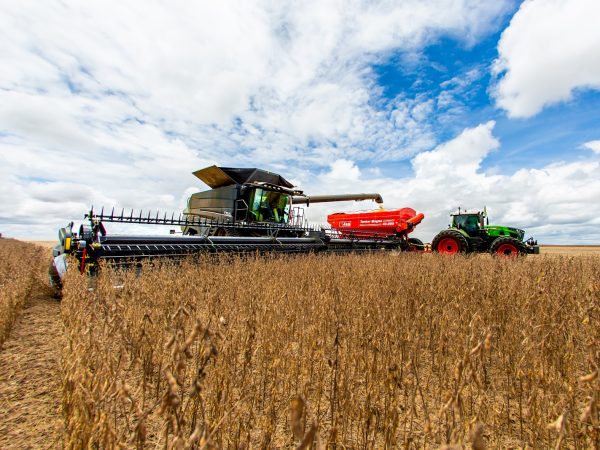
[50,166,420,289]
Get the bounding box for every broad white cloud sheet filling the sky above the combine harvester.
[0,0,511,237]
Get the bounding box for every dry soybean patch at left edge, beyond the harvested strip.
[0,239,48,349]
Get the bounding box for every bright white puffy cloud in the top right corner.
[494,0,600,117]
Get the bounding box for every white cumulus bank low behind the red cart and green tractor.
[307,122,600,244]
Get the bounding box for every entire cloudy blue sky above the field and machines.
[0,0,600,243]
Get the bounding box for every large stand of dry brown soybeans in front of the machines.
[62,252,600,449]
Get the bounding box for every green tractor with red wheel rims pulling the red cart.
[431,208,540,258]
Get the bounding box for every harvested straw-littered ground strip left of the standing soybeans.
[0,293,63,449]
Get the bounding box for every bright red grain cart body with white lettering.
[327,208,425,235]
